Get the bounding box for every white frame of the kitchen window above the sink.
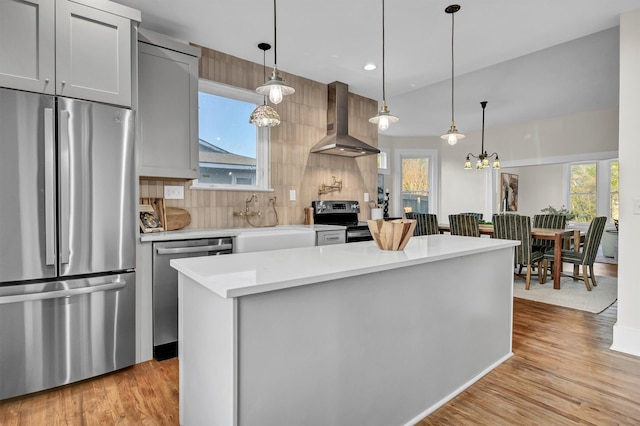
[191,78,273,191]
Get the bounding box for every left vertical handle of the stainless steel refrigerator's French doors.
[44,108,56,265]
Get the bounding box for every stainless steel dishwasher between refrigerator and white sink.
[152,237,233,360]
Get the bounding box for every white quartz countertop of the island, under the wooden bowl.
[171,235,520,298]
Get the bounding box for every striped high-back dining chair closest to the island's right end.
[492,214,545,290]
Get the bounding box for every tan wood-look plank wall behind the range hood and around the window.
[140,46,378,229]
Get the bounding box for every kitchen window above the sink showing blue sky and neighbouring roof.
[193,80,269,190]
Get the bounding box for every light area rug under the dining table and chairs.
[513,275,618,314]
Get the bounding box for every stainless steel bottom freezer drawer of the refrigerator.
[0,272,135,399]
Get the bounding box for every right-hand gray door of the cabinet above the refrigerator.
[56,1,131,107]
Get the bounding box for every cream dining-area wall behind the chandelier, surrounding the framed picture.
[378,103,618,222]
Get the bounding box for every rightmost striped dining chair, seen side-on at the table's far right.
[543,216,607,291]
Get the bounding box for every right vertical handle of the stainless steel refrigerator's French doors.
[59,111,71,265]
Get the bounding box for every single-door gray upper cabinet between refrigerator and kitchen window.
[138,29,200,179]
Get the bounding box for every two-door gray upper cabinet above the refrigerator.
[0,0,140,107]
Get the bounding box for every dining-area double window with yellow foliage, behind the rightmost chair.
[565,160,619,222]
